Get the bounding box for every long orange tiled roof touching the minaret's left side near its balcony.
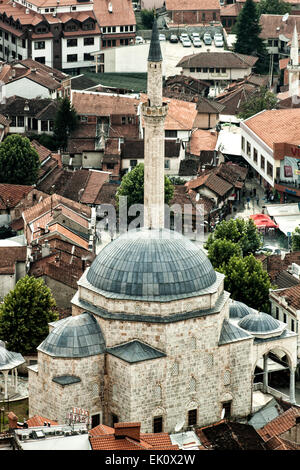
[72,91,139,116]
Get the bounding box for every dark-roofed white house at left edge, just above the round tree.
[0,96,58,135]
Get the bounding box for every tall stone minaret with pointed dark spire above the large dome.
[142,18,168,228]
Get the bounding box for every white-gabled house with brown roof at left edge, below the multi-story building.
[0,59,67,100]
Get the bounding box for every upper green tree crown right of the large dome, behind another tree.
[205,218,262,256]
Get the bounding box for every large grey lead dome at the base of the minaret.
[87,229,216,298]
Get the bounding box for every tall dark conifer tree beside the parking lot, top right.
[234,0,269,73]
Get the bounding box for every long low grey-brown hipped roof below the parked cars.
[176,52,258,69]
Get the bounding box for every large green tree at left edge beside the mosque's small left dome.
[0,276,57,355]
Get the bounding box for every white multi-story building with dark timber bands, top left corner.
[0,0,135,74]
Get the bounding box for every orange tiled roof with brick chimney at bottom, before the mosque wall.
[89,423,178,451]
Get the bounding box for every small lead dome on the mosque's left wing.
[37,313,105,358]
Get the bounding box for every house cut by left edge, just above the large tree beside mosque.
[0,246,26,300]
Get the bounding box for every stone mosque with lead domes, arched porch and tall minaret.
[28,22,297,433]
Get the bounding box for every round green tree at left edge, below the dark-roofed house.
[0,134,40,185]
